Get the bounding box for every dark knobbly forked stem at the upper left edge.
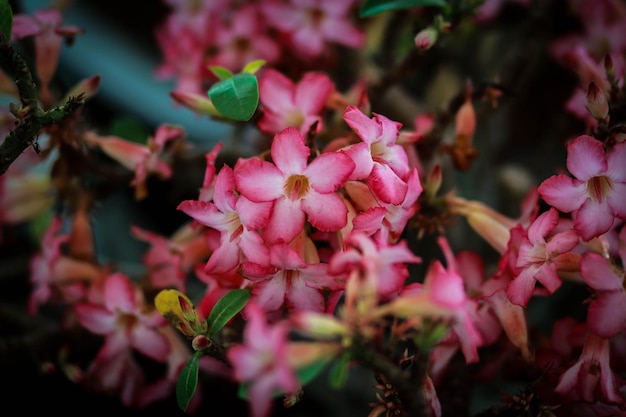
[0,33,84,175]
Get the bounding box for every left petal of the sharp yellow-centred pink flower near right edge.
[538,175,589,213]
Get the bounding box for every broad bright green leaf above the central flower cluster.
[209,72,259,121]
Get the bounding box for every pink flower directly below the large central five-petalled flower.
[241,243,344,312]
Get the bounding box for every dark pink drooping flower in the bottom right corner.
[555,331,624,403]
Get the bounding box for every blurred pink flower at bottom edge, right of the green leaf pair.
[227,303,299,417]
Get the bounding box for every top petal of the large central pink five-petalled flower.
[271,126,311,173]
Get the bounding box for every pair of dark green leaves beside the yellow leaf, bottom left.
[176,289,250,411]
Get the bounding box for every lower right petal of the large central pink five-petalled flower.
[302,190,348,232]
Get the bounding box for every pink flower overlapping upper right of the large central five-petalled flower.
[343,106,410,205]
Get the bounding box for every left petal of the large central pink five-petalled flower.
[235,157,284,202]
